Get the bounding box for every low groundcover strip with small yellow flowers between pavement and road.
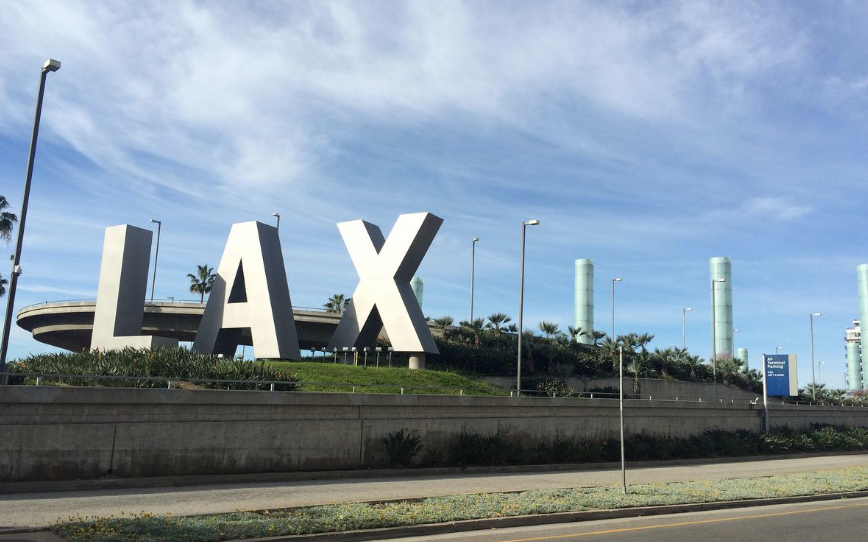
[54,467,868,542]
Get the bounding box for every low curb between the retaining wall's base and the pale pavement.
[0,450,868,498]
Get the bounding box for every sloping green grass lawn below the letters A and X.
[269,364,509,395]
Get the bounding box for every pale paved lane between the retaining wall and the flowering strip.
[0,454,868,532]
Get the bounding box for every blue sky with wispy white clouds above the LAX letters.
[0,0,868,387]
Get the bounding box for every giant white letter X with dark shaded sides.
[328,213,443,354]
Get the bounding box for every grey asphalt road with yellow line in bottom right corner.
[378,498,868,542]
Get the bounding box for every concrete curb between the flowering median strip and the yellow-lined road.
[220,490,868,542]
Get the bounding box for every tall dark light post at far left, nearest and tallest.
[0,58,60,385]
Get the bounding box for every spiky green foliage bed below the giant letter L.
[10,348,296,391]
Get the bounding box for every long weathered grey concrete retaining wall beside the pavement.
[0,386,868,482]
